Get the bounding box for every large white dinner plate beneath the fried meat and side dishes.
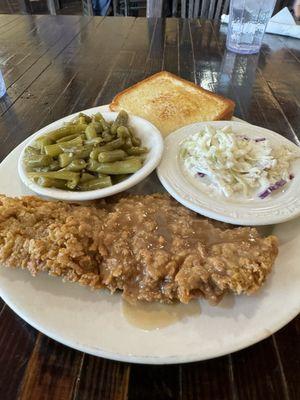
[0,108,300,364]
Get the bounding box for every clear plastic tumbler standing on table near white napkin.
[226,0,276,54]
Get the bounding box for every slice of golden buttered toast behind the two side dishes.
[110,71,235,136]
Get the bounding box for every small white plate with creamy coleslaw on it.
[157,121,300,225]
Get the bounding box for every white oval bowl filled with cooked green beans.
[18,107,163,201]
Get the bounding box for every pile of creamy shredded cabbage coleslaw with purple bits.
[180,126,299,197]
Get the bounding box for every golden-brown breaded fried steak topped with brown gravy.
[0,194,278,303]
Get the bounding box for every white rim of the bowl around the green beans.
[18,107,163,201]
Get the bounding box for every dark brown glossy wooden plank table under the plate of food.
[0,15,300,400]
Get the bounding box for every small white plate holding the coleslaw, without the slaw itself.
[157,121,300,225]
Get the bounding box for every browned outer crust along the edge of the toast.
[109,71,235,120]
